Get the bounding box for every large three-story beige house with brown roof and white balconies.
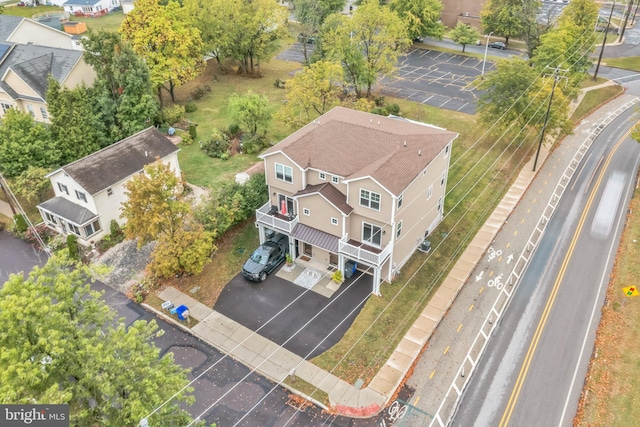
[256,107,457,295]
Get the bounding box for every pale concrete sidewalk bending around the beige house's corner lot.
[149,87,637,419]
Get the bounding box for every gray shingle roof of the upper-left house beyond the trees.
[0,44,82,100]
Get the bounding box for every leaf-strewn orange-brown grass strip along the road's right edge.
[574,191,640,427]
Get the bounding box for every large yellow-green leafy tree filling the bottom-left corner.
[0,254,198,427]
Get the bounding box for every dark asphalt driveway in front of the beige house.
[213,272,373,359]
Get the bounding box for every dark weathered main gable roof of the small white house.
[57,127,180,195]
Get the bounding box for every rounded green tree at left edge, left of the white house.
[0,108,60,177]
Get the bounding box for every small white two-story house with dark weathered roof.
[38,127,180,245]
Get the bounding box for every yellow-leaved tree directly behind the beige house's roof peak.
[278,61,344,129]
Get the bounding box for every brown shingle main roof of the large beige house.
[261,107,458,195]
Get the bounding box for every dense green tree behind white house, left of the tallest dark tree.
[46,77,105,164]
